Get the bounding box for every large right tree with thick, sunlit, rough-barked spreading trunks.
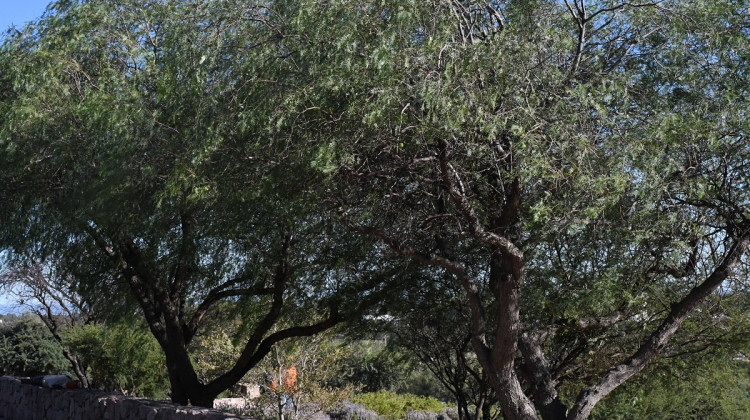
[262,0,750,419]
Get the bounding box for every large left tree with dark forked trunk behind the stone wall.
[0,0,392,406]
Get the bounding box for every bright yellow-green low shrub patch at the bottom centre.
[351,390,447,420]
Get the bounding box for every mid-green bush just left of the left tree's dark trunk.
[64,323,169,399]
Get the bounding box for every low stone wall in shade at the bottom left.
[0,377,251,420]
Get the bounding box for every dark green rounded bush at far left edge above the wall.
[0,316,70,376]
